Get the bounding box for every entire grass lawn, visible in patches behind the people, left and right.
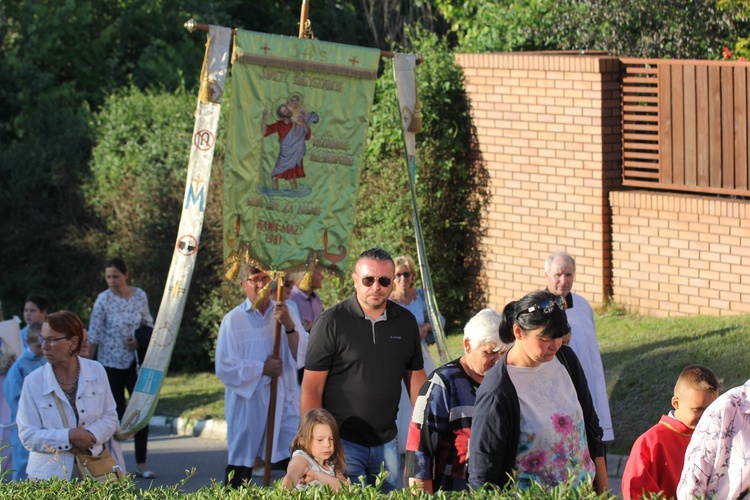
[155,312,750,455]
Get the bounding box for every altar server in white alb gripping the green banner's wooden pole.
[216,264,304,487]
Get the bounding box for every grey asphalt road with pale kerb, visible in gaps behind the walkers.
[122,417,627,495]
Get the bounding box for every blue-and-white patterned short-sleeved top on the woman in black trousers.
[89,288,154,370]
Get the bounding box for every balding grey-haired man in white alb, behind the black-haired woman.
[544,251,615,442]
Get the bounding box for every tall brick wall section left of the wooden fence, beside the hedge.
[456,53,621,309]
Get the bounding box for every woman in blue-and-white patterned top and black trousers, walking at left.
[88,258,156,479]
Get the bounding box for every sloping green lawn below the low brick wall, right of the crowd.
[596,314,750,455]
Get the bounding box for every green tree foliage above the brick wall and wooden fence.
[436,0,747,59]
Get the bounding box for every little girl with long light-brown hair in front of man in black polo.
[282,408,348,490]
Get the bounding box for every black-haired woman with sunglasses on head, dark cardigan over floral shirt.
[469,291,608,493]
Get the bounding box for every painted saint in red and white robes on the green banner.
[262,96,319,190]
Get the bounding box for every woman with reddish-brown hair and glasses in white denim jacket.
[16,311,122,479]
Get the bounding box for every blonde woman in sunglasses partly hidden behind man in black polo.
[389,255,445,453]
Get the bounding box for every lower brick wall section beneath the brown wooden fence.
[610,191,750,316]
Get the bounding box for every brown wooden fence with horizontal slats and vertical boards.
[620,58,750,196]
